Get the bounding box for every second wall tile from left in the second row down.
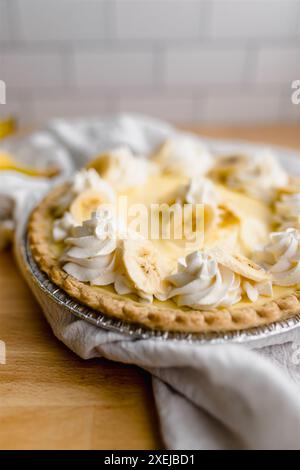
[74,49,154,88]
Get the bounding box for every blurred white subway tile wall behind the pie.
[0,0,300,125]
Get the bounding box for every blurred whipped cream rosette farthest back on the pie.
[152,136,213,178]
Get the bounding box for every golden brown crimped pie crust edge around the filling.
[28,186,300,333]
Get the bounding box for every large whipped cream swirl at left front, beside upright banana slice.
[61,210,117,286]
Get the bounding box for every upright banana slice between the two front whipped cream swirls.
[122,239,162,297]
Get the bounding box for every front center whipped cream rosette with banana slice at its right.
[166,248,272,310]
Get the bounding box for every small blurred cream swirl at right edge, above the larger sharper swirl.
[275,193,300,230]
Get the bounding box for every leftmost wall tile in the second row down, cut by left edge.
[0,50,64,88]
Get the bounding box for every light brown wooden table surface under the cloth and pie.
[0,125,300,450]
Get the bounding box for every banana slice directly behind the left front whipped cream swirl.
[70,189,111,224]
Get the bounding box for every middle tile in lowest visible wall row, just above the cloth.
[117,95,194,124]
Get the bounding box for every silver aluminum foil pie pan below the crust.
[20,230,300,347]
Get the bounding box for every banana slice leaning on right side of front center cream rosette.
[207,247,271,282]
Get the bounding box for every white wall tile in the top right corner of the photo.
[208,0,299,39]
